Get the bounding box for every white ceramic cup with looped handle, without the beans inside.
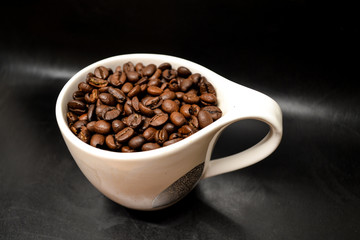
[56,54,282,210]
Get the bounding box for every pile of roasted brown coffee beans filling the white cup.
[67,62,222,152]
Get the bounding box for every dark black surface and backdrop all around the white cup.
[0,0,360,240]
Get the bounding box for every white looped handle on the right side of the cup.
[202,82,283,179]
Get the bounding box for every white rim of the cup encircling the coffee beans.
[55,53,230,161]
